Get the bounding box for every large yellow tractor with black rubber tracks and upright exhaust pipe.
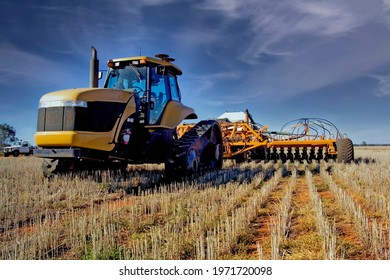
[34,47,223,177]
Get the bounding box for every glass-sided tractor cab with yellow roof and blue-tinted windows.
[104,54,182,125]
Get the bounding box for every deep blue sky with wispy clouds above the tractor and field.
[0,0,390,144]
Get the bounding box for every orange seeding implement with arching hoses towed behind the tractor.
[177,111,354,162]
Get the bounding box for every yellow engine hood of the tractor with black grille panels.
[35,88,136,151]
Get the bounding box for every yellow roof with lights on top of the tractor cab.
[107,54,183,75]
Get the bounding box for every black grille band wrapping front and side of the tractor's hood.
[37,102,126,132]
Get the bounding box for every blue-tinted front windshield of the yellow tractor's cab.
[106,65,146,93]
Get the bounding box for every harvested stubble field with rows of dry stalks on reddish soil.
[0,147,390,260]
